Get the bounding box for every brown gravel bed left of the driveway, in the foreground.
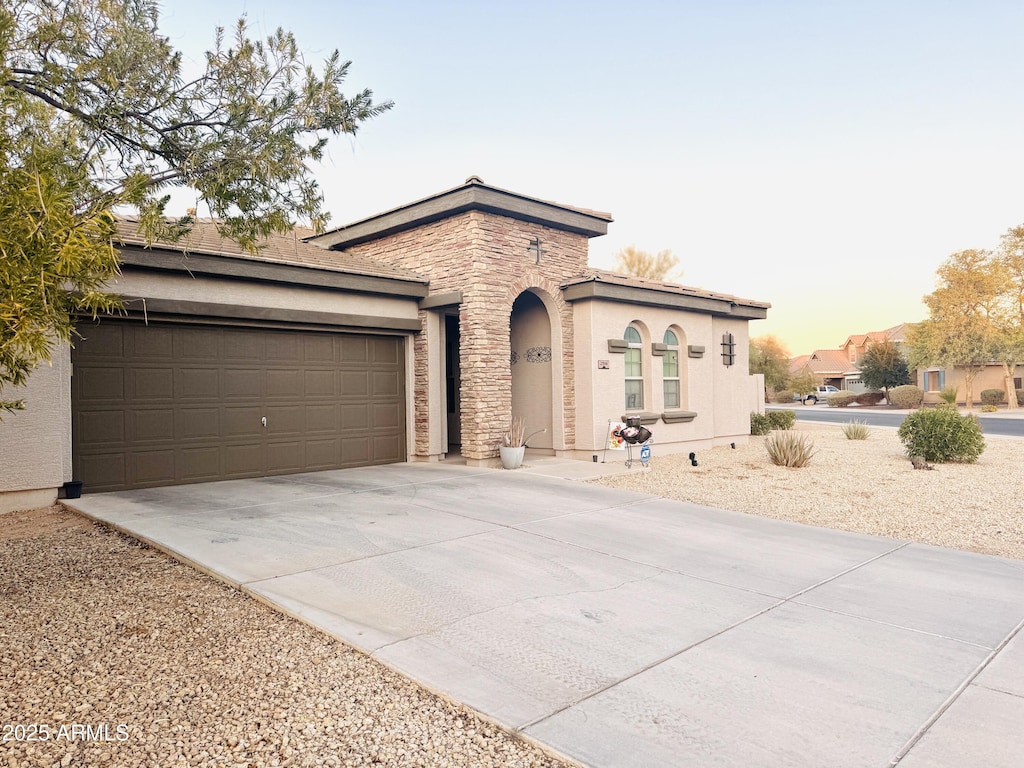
[0,507,566,768]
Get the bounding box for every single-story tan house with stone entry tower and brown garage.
[0,177,769,509]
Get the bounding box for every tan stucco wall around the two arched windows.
[573,301,756,458]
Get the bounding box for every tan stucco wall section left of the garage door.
[0,344,72,512]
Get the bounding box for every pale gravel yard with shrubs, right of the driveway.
[595,422,1024,559]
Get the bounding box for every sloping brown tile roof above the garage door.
[117,216,427,283]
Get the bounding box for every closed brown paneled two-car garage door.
[72,321,406,493]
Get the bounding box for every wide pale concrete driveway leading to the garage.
[69,462,1024,768]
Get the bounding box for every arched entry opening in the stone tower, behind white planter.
[509,290,557,449]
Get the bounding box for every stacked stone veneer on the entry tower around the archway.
[346,211,588,460]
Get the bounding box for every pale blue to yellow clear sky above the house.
[155,0,1024,355]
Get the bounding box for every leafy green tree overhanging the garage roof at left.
[0,0,391,410]
